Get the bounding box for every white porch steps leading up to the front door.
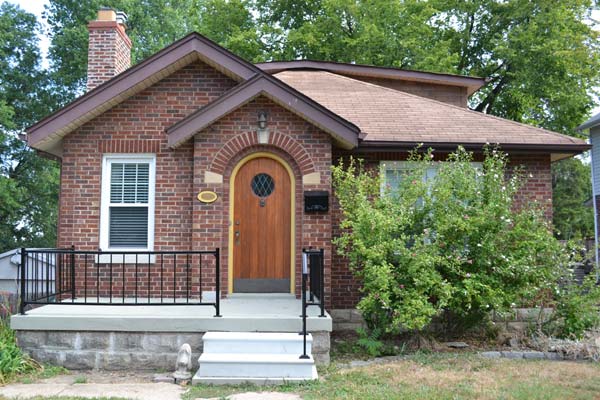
[192,332,317,385]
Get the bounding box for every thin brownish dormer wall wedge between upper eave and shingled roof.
[350,76,469,107]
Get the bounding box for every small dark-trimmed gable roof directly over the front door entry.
[167,74,360,149]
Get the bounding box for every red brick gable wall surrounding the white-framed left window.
[58,63,235,296]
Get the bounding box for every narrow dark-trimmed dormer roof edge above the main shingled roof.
[256,60,485,95]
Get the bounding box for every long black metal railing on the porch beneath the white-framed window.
[19,247,221,317]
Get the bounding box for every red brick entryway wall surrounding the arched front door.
[193,97,331,299]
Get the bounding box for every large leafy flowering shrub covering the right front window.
[332,149,565,333]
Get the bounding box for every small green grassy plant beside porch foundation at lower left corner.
[0,319,42,384]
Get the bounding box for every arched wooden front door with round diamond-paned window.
[233,157,292,293]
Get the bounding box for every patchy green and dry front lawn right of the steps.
[184,353,600,400]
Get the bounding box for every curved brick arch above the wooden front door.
[208,130,316,175]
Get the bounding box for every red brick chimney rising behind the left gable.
[87,8,131,91]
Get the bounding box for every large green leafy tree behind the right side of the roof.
[256,0,600,135]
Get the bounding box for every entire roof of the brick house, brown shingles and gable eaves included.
[27,33,589,159]
